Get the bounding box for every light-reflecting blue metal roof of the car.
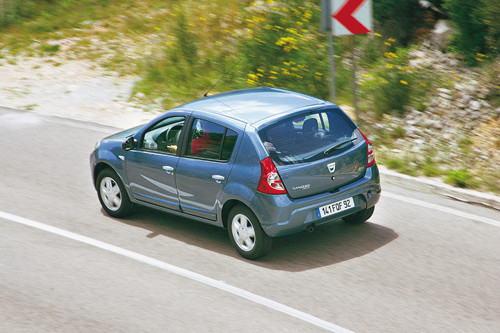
[178,87,331,124]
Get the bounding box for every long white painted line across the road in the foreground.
[0,211,353,333]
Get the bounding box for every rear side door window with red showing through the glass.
[187,119,238,161]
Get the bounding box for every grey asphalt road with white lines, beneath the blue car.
[0,109,500,332]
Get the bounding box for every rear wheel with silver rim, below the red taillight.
[227,205,272,259]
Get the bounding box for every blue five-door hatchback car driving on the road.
[90,88,380,259]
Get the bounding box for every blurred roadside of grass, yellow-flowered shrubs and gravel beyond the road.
[0,0,500,193]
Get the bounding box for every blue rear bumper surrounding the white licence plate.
[252,164,381,237]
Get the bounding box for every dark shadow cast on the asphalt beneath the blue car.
[109,207,398,272]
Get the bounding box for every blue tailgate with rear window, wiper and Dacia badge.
[259,108,367,198]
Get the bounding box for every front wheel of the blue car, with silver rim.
[96,169,133,217]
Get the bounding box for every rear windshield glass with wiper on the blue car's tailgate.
[259,109,359,165]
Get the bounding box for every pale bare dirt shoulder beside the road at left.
[0,57,159,128]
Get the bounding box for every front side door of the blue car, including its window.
[126,115,185,210]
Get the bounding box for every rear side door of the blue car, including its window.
[176,119,238,220]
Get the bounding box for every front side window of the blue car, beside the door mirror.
[141,117,185,154]
